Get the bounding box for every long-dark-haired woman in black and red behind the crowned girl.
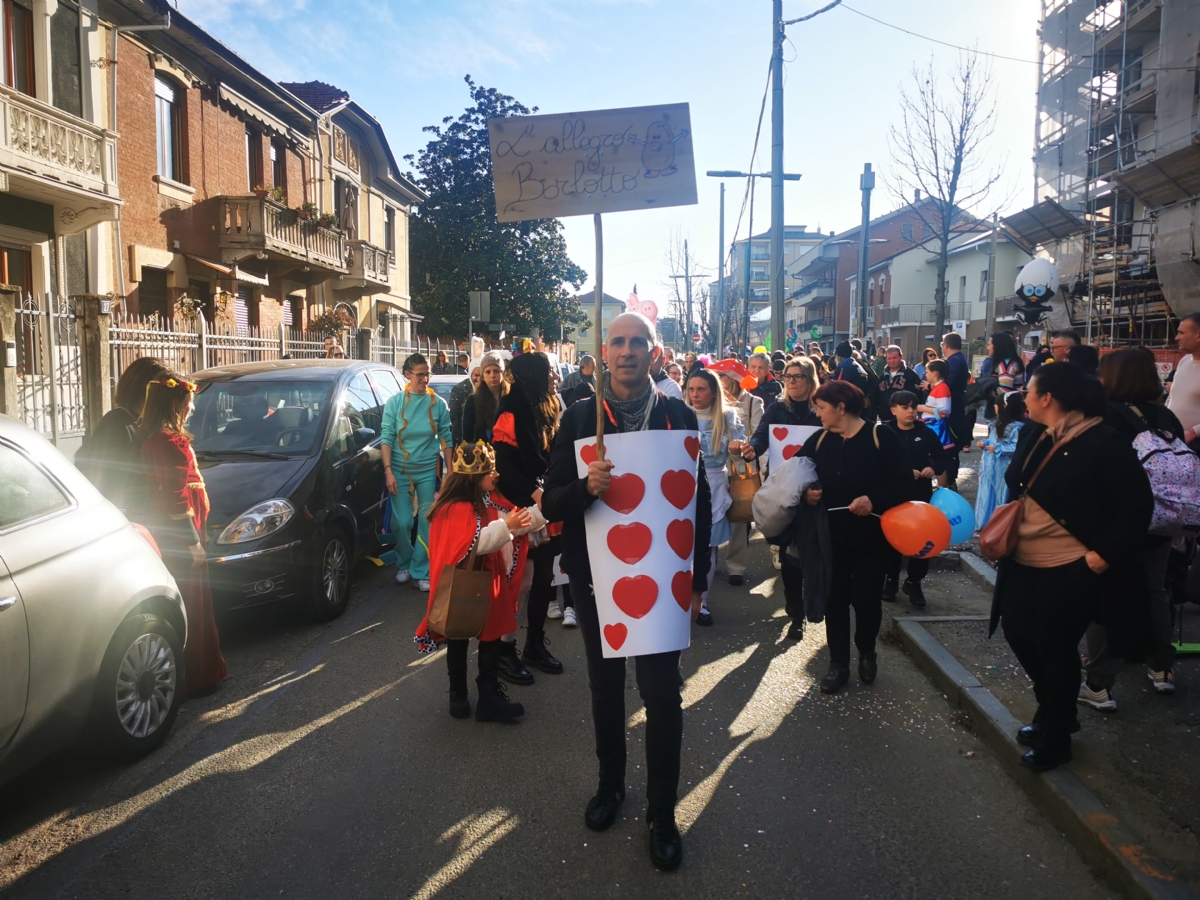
[492,353,563,684]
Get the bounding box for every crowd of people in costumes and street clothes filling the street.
[72,313,1200,870]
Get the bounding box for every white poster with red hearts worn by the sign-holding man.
[575,431,700,658]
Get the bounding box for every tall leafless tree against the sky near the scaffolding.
[888,53,1001,335]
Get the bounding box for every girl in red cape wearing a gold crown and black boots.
[415,440,546,722]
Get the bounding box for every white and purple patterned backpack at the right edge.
[1120,404,1200,535]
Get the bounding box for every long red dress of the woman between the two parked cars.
[142,431,228,697]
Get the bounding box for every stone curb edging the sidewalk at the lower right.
[892,624,1198,900]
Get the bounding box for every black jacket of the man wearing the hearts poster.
[540,394,713,592]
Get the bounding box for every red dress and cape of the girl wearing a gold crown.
[414,491,529,653]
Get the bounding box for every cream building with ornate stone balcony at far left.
[0,0,122,303]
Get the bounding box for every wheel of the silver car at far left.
[92,613,185,758]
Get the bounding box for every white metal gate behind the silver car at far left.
[17,294,85,444]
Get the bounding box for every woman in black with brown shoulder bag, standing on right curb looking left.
[991,365,1154,770]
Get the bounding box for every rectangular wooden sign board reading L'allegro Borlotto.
[487,103,696,222]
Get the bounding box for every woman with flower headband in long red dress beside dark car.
[136,373,227,697]
